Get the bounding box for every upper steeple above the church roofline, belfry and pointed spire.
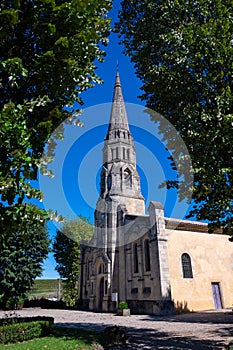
[98,70,145,214]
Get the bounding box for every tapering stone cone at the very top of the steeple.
[106,69,129,139]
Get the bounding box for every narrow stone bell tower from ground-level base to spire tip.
[89,71,145,311]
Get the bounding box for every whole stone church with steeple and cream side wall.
[79,73,233,314]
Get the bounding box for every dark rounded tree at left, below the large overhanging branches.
[0,206,49,309]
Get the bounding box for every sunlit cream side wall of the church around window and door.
[167,230,233,310]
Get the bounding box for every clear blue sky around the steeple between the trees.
[40,0,193,278]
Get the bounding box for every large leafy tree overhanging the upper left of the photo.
[0,0,111,300]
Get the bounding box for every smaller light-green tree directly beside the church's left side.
[53,216,94,306]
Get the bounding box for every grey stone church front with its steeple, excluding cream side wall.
[80,71,172,313]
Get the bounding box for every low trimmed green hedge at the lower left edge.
[0,317,53,344]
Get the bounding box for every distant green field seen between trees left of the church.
[29,279,62,299]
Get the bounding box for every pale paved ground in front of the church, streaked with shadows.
[0,308,233,350]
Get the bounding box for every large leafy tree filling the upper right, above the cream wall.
[116,0,233,233]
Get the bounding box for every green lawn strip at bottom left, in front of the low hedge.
[0,327,101,350]
